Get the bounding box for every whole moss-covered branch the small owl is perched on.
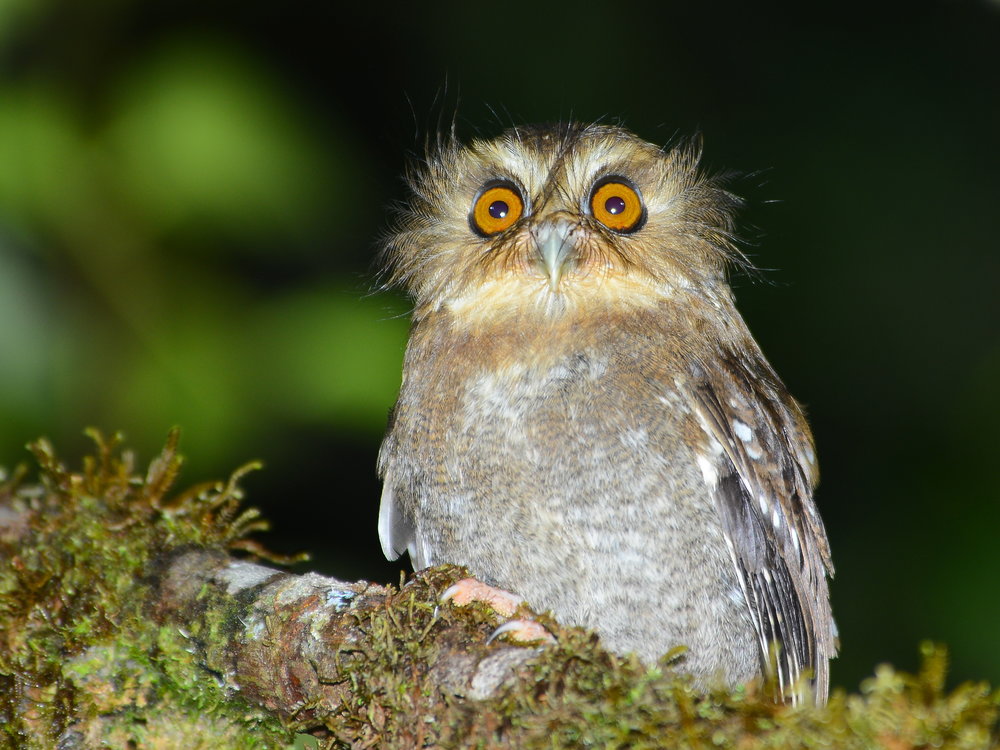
[0,432,1000,750]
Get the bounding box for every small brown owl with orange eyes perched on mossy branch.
[379,124,836,703]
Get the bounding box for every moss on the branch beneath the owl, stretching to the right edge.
[320,584,1000,750]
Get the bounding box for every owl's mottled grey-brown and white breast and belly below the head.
[383,308,759,682]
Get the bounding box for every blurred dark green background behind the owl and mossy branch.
[0,0,1000,686]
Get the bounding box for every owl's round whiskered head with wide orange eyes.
[385,123,743,317]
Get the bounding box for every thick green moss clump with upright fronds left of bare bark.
[0,431,291,748]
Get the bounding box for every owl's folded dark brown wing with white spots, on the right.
[688,352,836,703]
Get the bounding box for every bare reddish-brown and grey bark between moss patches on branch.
[154,550,538,729]
